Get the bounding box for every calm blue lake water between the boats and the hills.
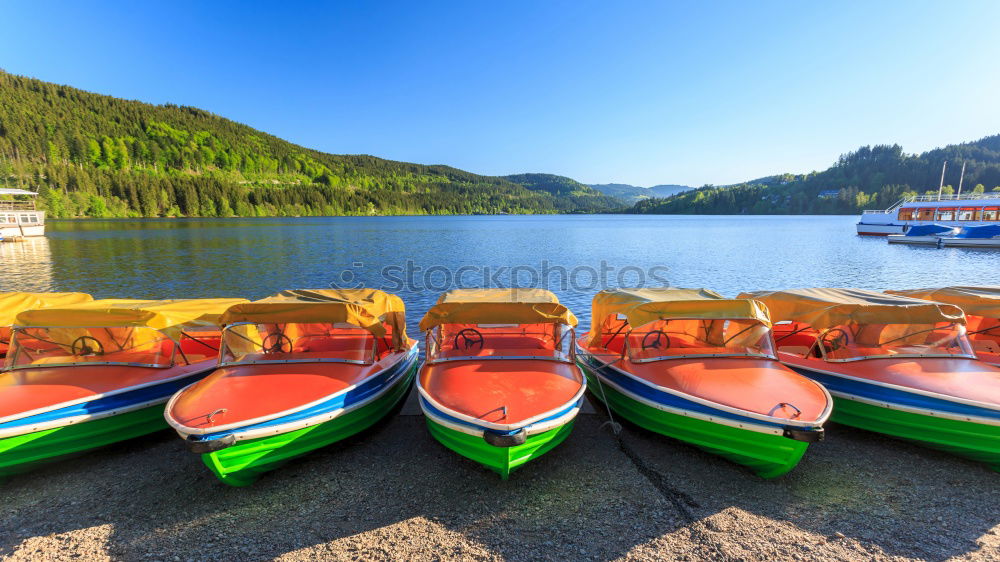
[0,215,1000,325]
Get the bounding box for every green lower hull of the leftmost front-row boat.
[0,404,167,478]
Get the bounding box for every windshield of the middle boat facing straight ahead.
[427,323,574,363]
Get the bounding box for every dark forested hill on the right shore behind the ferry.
[629,139,1000,214]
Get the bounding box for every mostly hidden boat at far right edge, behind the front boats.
[886,287,1000,367]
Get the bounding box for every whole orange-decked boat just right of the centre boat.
[577,288,833,478]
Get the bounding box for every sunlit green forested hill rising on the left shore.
[0,71,615,217]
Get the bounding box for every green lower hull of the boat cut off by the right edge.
[831,396,1000,472]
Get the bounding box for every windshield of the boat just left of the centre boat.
[220,323,384,365]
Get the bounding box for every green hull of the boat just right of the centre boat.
[581,364,809,478]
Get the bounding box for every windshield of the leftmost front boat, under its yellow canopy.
[5,326,181,369]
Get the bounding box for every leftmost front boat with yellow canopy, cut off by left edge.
[0,299,241,478]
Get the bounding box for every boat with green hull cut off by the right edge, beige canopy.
[741,289,1000,471]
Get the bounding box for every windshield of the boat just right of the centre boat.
[624,318,775,363]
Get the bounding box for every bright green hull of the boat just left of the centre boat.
[201,362,417,487]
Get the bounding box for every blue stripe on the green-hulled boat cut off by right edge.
[787,365,1000,420]
